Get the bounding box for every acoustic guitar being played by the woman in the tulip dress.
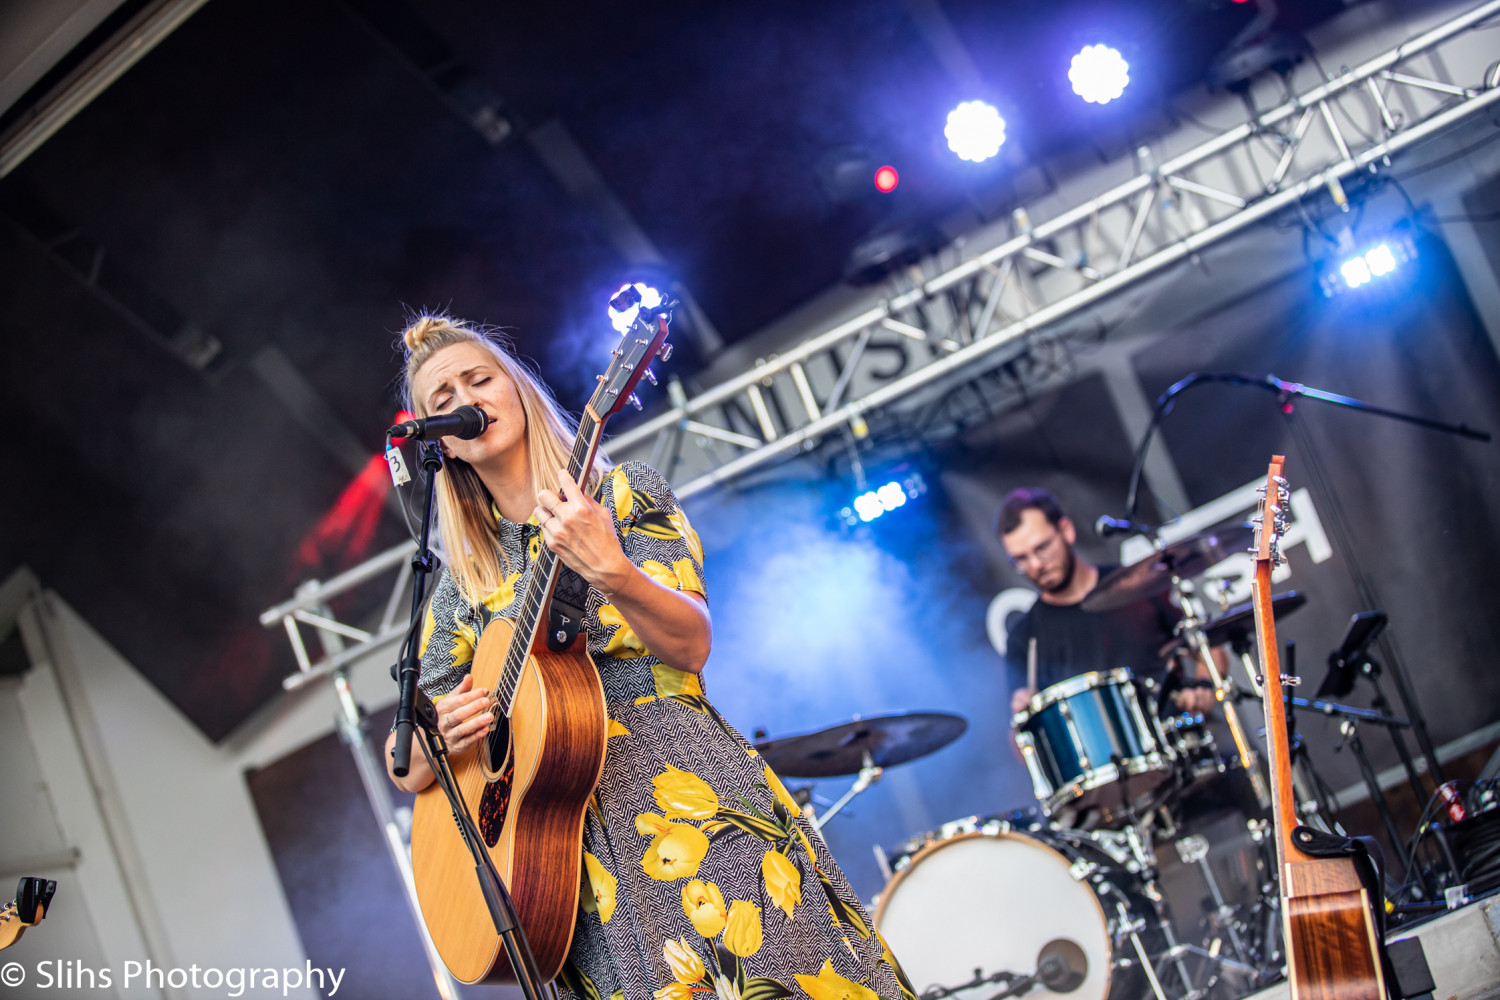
[411,299,671,984]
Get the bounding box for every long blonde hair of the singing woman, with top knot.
[402,313,611,604]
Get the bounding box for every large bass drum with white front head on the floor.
[875,828,1163,1000]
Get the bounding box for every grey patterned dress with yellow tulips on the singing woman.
[422,462,915,1000]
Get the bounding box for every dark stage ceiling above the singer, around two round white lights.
[0,0,1380,739]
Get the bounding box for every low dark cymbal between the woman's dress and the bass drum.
[755,712,969,778]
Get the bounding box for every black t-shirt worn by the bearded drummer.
[1005,567,1181,701]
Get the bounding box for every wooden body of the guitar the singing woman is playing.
[411,618,608,984]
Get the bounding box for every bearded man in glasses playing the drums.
[999,487,1217,715]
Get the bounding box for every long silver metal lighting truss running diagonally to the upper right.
[609,1,1500,498]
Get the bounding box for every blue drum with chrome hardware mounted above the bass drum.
[1013,669,1175,816]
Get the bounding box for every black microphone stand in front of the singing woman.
[390,441,545,1000]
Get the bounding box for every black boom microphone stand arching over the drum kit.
[1125,372,1491,803]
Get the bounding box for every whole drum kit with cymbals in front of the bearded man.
[756,526,1374,1000]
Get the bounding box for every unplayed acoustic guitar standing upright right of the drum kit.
[1253,454,1386,1000]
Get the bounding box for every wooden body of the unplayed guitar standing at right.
[1281,858,1386,1000]
